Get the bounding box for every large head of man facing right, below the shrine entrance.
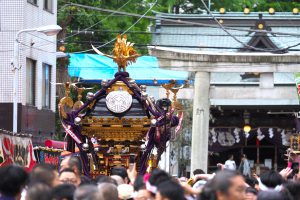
[199,170,246,200]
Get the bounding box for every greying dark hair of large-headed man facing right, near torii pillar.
[198,170,241,200]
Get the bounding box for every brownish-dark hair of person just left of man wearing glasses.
[30,164,56,187]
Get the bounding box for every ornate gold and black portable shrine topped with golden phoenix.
[59,35,183,176]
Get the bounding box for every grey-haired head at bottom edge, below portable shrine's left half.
[74,185,103,200]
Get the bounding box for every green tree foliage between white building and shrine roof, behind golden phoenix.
[58,0,152,54]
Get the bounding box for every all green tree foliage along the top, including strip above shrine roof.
[57,0,300,54]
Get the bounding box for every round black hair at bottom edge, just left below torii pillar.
[157,180,185,200]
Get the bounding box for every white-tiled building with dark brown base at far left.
[0,0,57,143]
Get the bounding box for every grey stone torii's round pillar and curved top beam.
[149,47,300,171]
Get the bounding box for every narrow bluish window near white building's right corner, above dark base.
[42,63,52,108]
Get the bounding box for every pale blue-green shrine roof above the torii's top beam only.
[152,13,300,51]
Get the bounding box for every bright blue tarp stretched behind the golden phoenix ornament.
[68,53,188,81]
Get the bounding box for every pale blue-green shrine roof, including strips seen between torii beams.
[152,12,300,84]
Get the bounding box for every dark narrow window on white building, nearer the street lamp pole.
[26,58,36,106]
